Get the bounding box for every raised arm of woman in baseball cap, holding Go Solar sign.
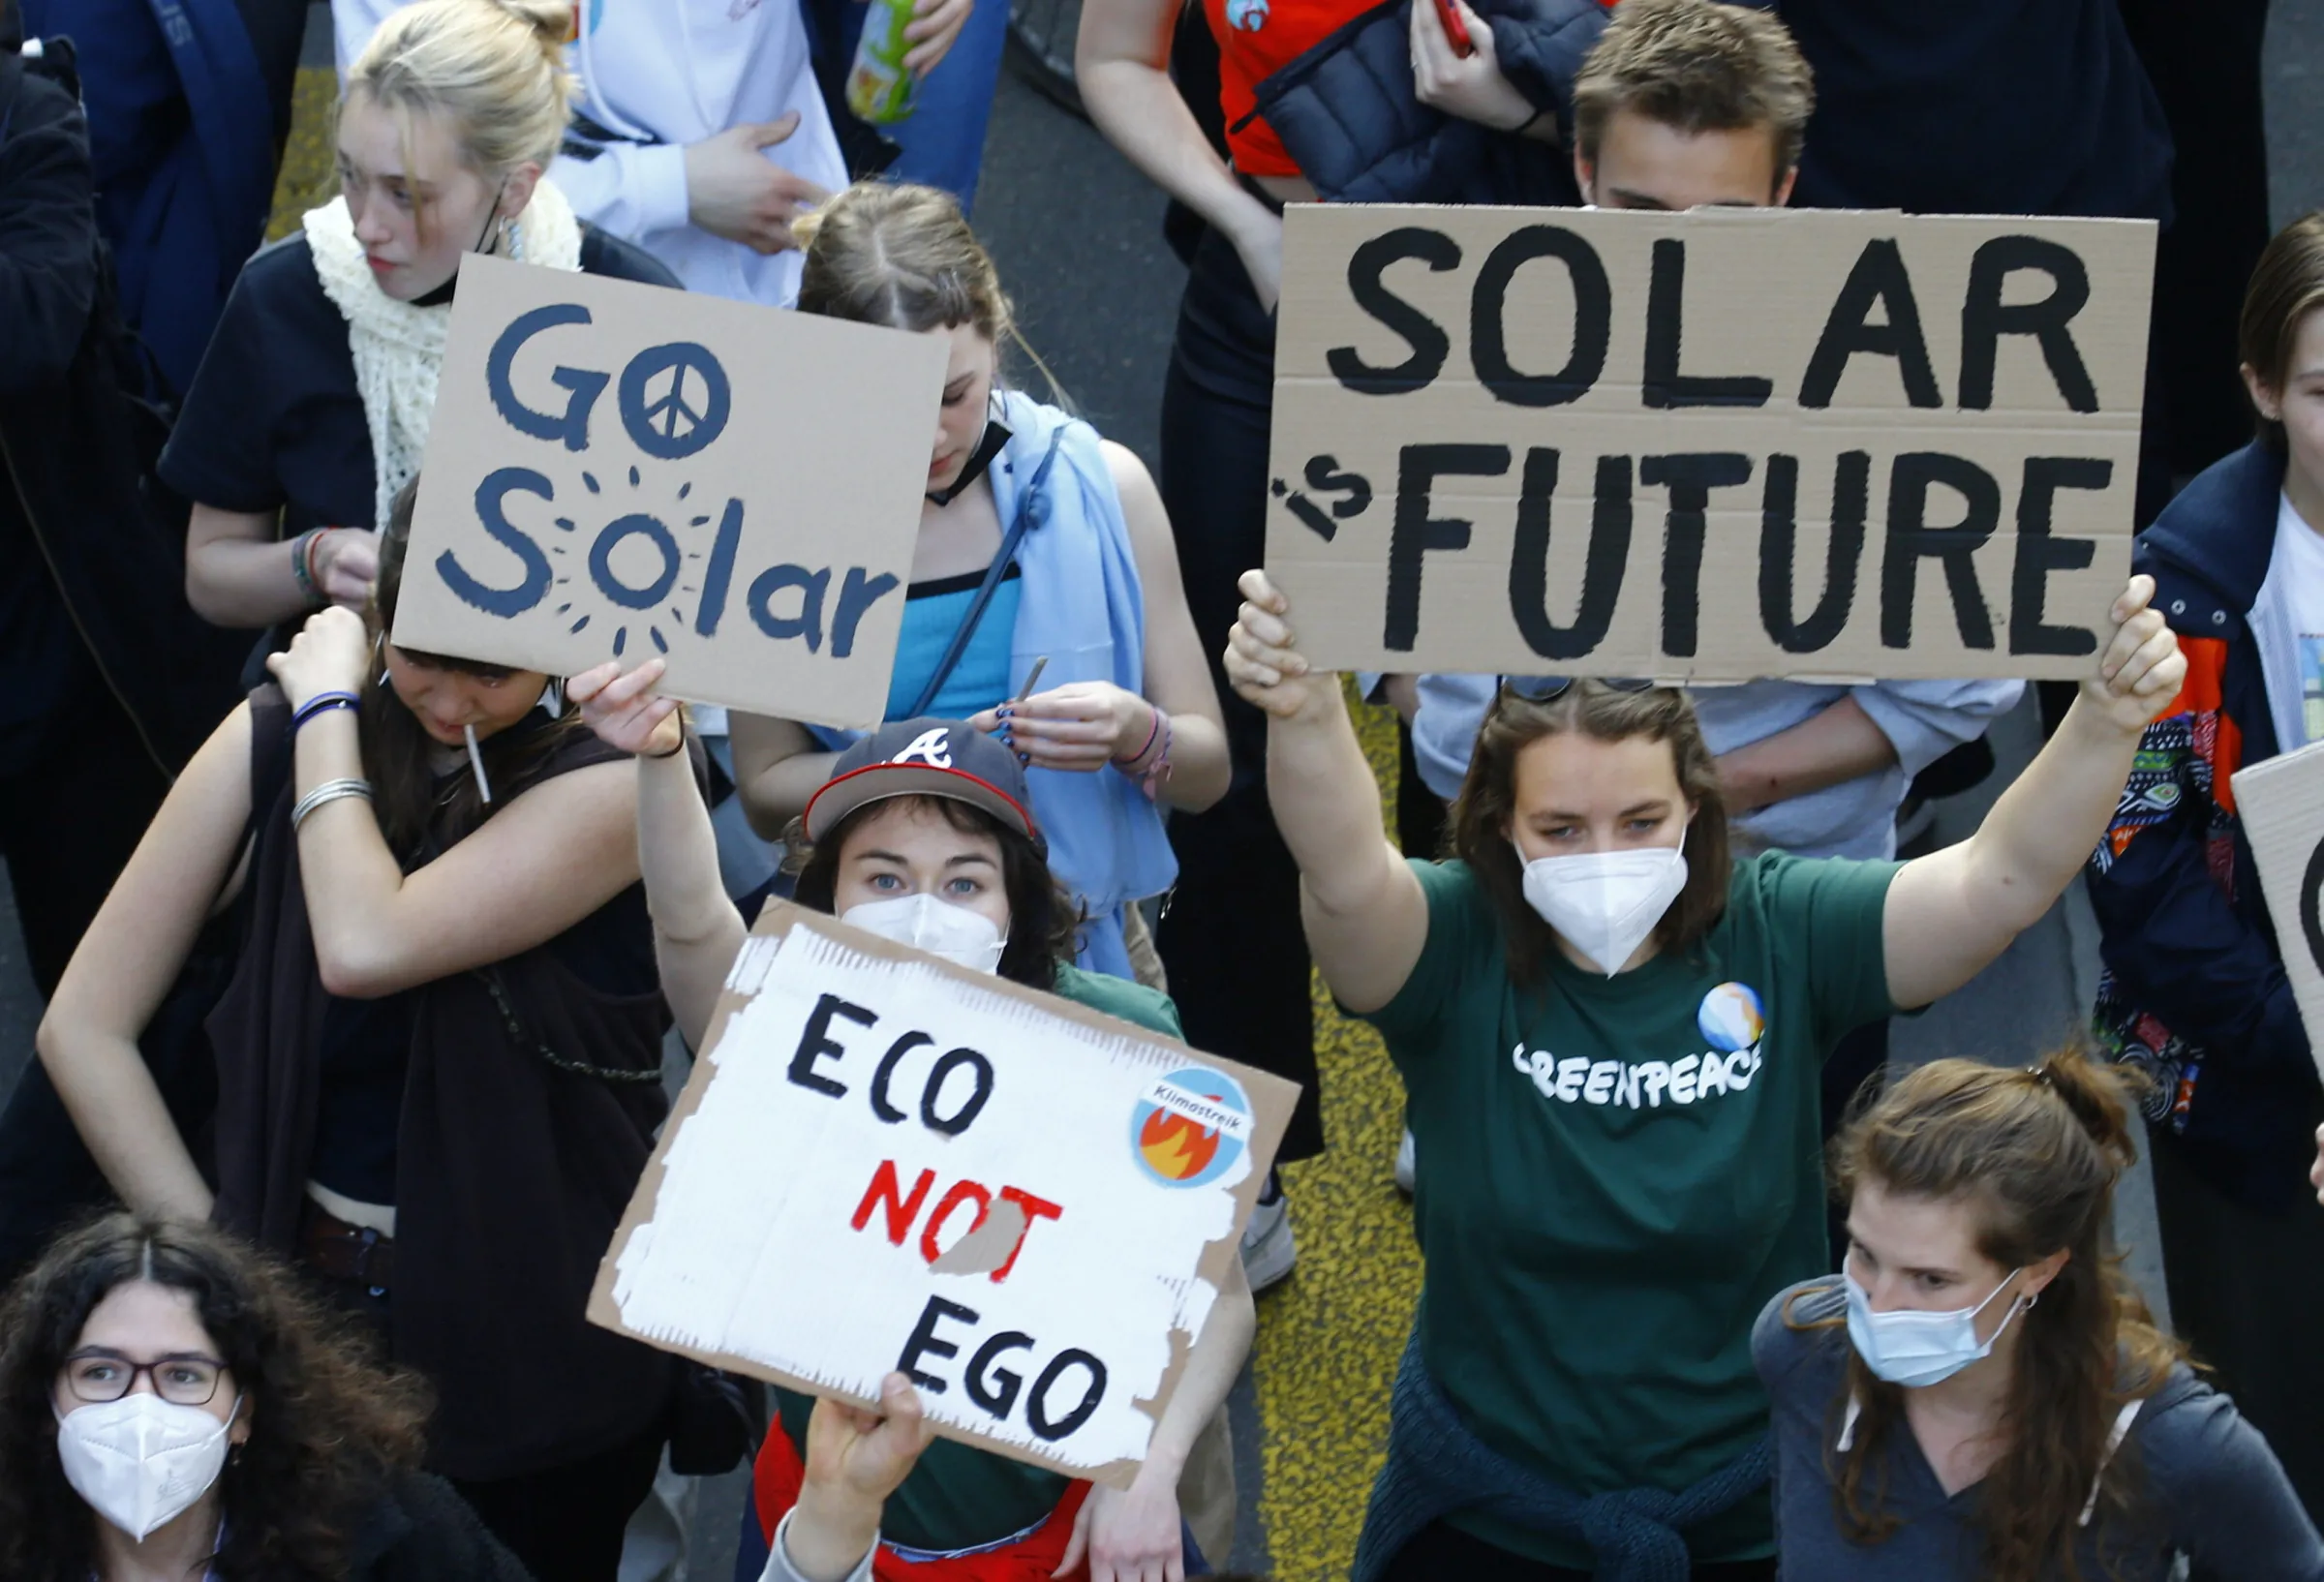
[565,657,744,1050]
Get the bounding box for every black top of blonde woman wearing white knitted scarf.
[161,226,679,539]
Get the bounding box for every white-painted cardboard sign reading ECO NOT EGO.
[588,903,1300,1487]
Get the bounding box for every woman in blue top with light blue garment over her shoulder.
[734,184,1227,978]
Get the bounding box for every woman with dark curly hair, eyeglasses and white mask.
[0,1212,528,1582]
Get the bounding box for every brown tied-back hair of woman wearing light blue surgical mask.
[1826,1050,2178,1582]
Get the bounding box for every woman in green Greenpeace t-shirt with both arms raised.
[1227,571,2185,1582]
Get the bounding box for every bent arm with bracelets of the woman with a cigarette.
[267,609,637,999]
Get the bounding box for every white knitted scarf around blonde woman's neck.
[307,179,581,528]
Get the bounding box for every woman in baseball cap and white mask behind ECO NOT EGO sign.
[567,659,1257,1577]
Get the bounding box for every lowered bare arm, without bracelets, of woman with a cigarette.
[35,706,251,1220]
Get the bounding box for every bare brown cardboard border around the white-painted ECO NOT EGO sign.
[588,901,1300,1489]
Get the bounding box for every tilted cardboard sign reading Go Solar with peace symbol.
[395,254,946,725]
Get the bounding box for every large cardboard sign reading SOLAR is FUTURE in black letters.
[1267,204,2155,681]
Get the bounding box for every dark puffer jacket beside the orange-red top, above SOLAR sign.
[1257,0,1605,204]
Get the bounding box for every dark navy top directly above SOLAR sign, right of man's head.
[1753,0,2171,221]
